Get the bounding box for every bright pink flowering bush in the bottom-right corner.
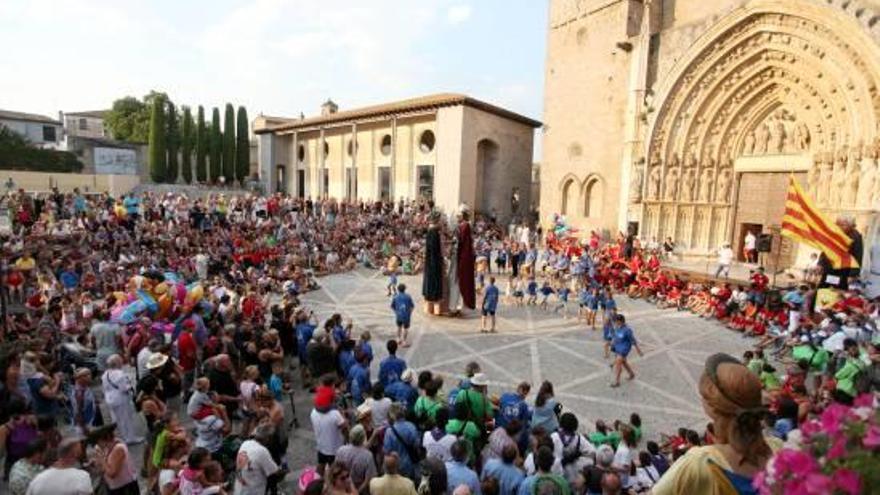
[754,394,880,495]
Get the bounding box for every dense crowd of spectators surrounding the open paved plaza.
[0,187,878,495]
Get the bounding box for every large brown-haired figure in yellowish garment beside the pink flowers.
[653,354,772,495]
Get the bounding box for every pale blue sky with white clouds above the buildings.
[0,0,547,155]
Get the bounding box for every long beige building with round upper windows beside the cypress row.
[254,94,541,219]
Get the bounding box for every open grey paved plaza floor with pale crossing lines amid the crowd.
[294,270,749,458]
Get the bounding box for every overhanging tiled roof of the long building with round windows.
[256,93,542,134]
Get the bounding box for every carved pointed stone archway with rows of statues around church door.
[635,0,880,260]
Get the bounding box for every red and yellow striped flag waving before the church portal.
[781,175,859,269]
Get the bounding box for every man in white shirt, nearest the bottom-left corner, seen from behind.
[25,435,92,495]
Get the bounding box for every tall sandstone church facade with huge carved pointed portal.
[541,0,880,271]
